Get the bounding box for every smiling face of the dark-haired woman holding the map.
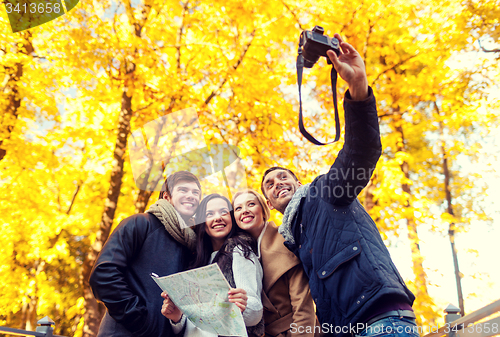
[205,198,233,250]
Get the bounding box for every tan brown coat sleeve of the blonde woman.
[286,264,316,337]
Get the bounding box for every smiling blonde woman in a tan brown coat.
[233,189,320,337]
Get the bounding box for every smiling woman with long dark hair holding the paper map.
[162,194,264,337]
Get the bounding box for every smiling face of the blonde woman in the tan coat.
[234,193,264,238]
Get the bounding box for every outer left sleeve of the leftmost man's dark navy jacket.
[89,215,153,336]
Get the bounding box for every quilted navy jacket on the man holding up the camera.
[285,88,415,332]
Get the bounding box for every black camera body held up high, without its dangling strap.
[299,26,340,68]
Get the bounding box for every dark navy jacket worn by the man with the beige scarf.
[90,213,190,337]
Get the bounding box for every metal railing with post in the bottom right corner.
[424,300,500,337]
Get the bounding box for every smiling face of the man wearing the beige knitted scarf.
[164,180,201,218]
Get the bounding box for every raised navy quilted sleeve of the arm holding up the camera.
[309,88,382,206]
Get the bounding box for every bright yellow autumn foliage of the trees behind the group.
[0,0,500,336]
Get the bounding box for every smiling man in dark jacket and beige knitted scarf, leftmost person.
[90,171,201,337]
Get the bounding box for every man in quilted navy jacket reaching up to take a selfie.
[261,34,418,336]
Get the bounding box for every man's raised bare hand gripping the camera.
[326,33,368,101]
